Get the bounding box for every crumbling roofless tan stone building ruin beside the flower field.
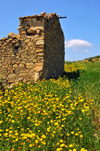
[0,12,65,88]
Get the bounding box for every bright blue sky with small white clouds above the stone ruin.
[0,0,100,61]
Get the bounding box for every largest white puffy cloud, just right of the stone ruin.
[65,39,93,47]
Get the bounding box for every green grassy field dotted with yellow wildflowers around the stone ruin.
[0,62,100,151]
